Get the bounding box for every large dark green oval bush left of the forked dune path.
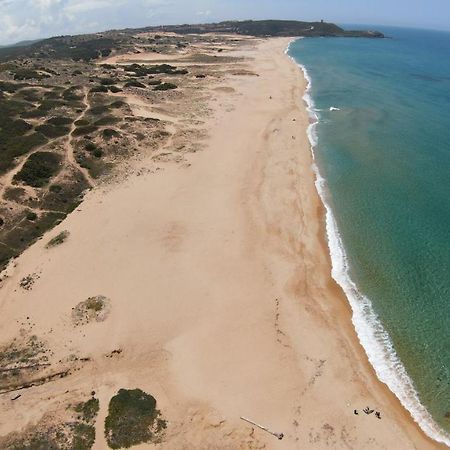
[14,152,61,187]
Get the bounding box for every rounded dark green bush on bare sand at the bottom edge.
[105,389,167,449]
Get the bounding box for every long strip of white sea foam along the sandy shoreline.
[286,42,450,446]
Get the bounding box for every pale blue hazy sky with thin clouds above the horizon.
[0,0,450,44]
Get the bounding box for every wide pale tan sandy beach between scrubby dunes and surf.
[0,38,441,450]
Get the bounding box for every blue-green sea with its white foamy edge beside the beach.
[289,27,450,446]
